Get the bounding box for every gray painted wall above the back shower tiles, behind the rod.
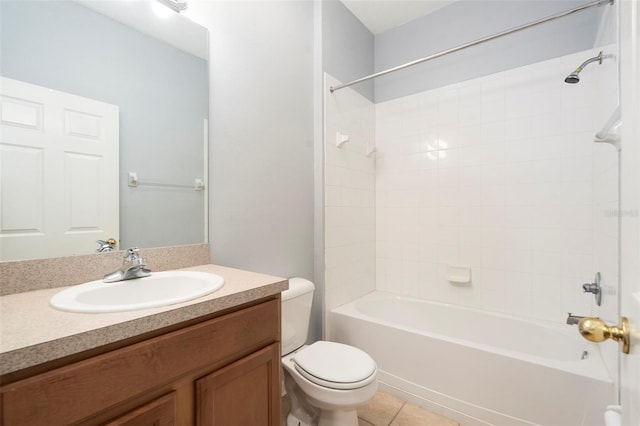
[375,0,609,102]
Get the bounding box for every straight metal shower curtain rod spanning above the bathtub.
[329,0,614,93]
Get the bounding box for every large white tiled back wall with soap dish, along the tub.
[378,49,617,321]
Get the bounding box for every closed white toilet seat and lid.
[293,341,376,389]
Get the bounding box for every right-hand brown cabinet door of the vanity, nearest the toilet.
[196,343,280,426]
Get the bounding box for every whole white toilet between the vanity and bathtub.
[282,278,378,426]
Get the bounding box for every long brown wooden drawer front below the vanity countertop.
[0,299,280,426]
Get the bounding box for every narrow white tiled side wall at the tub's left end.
[324,74,375,309]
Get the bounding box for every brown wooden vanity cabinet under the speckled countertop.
[0,296,281,426]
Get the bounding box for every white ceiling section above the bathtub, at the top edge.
[341,0,457,34]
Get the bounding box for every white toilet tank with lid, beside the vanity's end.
[281,278,315,355]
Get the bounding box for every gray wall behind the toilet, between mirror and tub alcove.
[189,1,314,306]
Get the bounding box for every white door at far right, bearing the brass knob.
[618,0,640,426]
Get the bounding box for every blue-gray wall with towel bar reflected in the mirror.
[0,1,208,250]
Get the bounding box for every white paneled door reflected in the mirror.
[0,77,119,261]
